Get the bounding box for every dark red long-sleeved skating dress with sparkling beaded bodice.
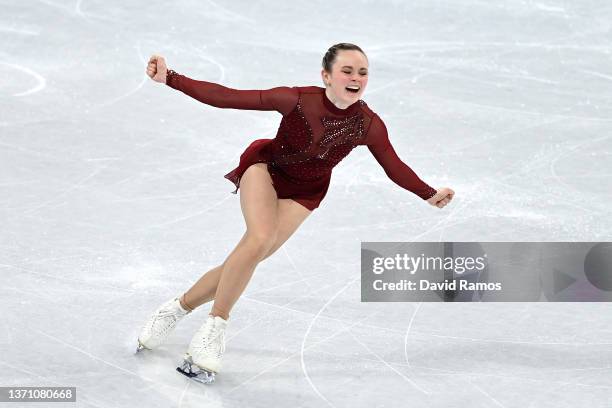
[166,70,436,210]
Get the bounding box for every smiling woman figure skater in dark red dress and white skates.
[138,43,455,383]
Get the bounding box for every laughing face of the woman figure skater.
[321,50,368,109]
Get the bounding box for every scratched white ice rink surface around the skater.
[0,0,612,408]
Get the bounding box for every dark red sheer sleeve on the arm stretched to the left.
[166,69,299,116]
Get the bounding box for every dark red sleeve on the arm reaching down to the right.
[366,115,437,200]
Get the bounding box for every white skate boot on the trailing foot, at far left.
[136,297,191,353]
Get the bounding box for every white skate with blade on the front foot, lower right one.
[176,315,227,384]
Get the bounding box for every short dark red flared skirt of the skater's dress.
[224,139,331,211]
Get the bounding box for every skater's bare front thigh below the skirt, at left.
[240,163,278,241]
